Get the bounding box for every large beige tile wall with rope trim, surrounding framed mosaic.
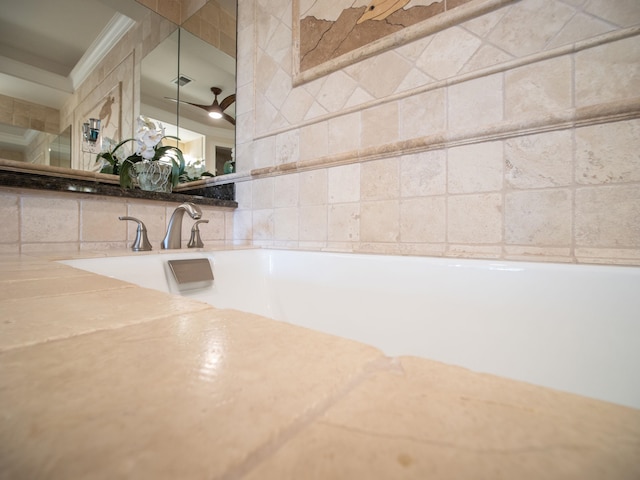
[234,0,640,264]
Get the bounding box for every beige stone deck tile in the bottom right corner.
[246,358,640,480]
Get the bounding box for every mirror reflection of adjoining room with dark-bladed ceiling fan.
[140,24,236,180]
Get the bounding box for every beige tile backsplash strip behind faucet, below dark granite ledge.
[0,187,233,254]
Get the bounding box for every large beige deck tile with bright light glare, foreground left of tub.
[0,309,380,479]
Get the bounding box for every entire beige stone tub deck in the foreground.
[0,252,640,480]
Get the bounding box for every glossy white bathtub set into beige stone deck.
[62,249,640,408]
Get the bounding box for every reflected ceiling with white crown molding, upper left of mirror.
[0,0,146,109]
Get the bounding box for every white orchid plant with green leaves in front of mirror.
[96,115,185,188]
